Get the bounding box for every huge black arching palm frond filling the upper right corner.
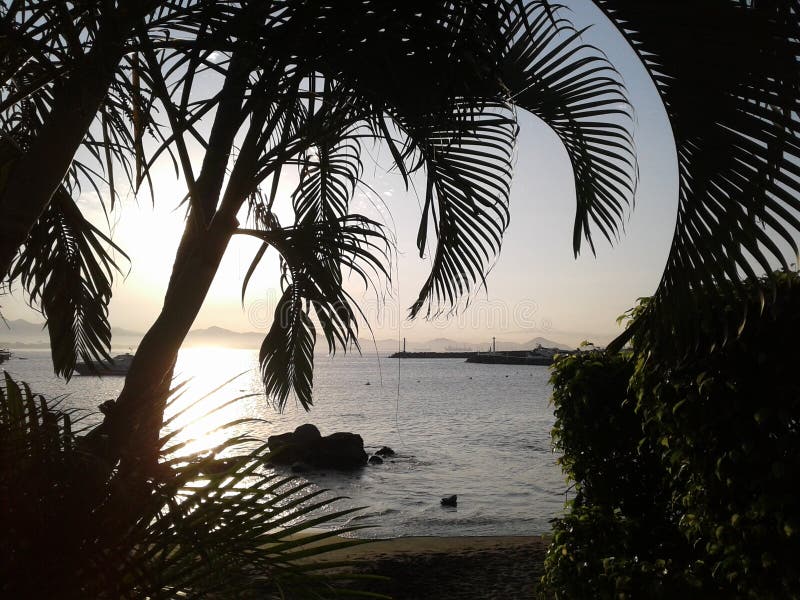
[596,0,800,353]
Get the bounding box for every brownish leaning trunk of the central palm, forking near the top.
[81,43,266,471]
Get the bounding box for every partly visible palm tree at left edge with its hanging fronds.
[0,0,236,377]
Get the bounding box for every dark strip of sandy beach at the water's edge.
[318,536,547,600]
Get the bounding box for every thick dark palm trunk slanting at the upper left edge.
[0,45,121,279]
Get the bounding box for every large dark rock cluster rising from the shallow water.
[267,424,367,470]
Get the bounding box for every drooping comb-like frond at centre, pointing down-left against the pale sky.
[399,100,518,318]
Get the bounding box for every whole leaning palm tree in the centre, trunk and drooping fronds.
[83,2,633,461]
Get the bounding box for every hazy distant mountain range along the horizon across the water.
[0,319,571,354]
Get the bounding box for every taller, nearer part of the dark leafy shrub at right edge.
[634,275,800,598]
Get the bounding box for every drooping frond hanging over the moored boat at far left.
[10,187,127,378]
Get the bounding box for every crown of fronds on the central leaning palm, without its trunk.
[206,1,634,406]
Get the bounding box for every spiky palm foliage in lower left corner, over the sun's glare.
[0,374,380,599]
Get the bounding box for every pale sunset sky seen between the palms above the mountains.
[2,1,677,344]
